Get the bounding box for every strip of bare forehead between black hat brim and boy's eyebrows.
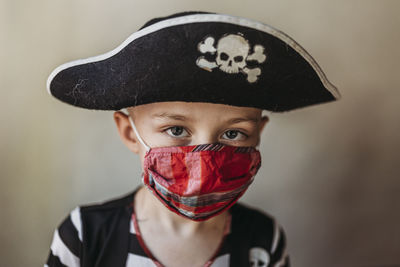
[128,101,262,118]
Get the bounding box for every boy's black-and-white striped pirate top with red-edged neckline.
[45,192,289,267]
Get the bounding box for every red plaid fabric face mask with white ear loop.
[129,117,261,221]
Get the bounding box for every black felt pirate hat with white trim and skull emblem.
[47,12,339,111]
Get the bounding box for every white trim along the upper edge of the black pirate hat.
[47,14,340,99]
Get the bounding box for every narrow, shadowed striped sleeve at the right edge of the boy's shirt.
[269,221,290,267]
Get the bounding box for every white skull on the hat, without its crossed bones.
[216,34,250,73]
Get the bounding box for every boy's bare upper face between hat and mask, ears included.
[114,102,268,163]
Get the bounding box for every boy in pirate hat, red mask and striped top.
[47,12,338,267]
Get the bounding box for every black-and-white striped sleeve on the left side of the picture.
[44,207,82,267]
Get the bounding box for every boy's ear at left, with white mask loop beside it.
[114,111,140,154]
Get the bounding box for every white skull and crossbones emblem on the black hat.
[196,33,267,83]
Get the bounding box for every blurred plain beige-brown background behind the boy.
[0,0,400,267]
